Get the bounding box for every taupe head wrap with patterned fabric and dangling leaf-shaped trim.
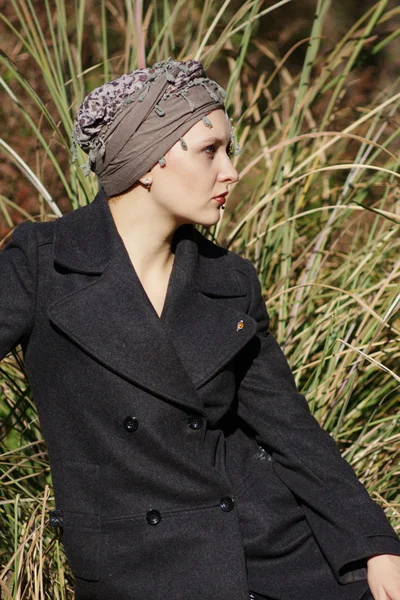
[71,58,240,197]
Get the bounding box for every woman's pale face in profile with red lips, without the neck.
[151,109,238,227]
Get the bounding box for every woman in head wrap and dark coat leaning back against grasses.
[0,59,400,600]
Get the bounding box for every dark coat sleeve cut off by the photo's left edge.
[0,222,37,360]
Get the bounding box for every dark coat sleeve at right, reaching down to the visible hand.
[234,259,400,583]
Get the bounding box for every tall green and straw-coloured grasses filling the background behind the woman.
[0,0,400,600]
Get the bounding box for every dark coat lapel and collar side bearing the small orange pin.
[164,237,256,389]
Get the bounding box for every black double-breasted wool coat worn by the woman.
[0,191,400,600]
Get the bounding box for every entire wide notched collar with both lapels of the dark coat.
[48,190,256,414]
